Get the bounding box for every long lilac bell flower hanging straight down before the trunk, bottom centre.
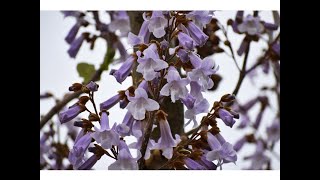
[151,119,181,159]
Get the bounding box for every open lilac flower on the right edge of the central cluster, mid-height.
[188,57,219,91]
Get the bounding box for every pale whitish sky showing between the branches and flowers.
[40,11,280,169]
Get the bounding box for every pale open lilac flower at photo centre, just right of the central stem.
[160,66,189,103]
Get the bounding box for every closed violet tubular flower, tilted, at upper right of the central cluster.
[187,21,209,47]
